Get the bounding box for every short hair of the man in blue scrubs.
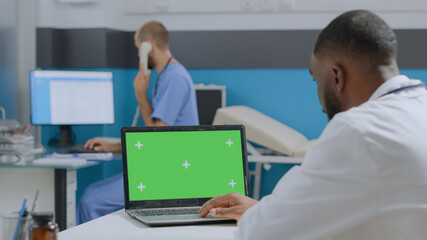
[136,21,169,50]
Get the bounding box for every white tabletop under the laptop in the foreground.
[59,209,236,240]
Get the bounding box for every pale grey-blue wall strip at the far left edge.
[0,0,36,125]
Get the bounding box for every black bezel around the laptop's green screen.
[121,125,249,209]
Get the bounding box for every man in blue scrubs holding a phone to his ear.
[77,21,199,224]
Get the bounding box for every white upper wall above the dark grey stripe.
[37,0,427,30]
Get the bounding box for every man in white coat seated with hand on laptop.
[200,10,427,240]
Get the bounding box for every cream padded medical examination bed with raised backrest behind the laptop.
[213,106,316,200]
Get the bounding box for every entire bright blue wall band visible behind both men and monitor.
[43,69,427,201]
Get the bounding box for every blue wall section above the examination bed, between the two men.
[190,69,327,139]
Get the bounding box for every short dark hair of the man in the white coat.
[313,10,397,66]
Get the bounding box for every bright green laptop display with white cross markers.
[125,130,245,201]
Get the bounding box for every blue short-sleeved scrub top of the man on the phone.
[151,63,199,126]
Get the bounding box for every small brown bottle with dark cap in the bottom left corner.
[29,212,58,240]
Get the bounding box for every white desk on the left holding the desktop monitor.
[0,153,121,233]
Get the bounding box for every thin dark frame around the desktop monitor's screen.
[28,69,116,126]
